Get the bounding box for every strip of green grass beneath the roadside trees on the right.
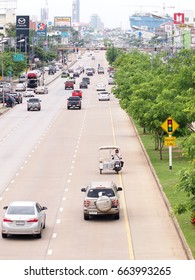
[134,122,195,258]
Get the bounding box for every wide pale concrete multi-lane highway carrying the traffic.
[0,52,188,260]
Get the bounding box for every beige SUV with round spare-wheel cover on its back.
[81,181,122,220]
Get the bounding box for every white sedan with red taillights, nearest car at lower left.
[1,201,47,238]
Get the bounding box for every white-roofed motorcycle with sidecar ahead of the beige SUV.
[99,146,124,174]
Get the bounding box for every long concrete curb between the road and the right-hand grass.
[129,116,194,260]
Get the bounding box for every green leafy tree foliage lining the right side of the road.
[110,47,195,219]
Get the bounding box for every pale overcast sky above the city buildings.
[17,0,195,29]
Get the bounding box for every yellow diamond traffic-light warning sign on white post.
[161,117,179,170]
